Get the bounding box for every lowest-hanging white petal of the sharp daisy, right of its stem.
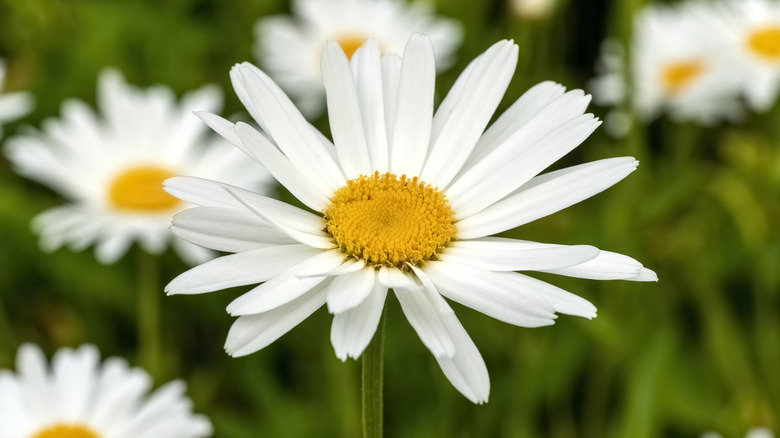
[436,313,490,404]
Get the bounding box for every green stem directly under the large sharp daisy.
[362,309,387,438]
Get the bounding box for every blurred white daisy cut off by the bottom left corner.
[0,344,212,438]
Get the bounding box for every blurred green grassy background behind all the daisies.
[0,0,780,438]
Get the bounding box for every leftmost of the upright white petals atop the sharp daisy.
[321,41,371,179]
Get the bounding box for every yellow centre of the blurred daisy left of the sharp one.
[108,165,181,213]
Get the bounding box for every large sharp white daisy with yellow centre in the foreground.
[165,35,656,403]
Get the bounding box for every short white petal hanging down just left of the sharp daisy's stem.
[330,281,387,361]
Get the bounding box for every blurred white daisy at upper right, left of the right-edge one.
[589,1,741,125]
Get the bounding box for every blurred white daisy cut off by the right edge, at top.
[723,0,780,111]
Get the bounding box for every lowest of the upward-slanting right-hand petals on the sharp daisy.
[457,157,639,239]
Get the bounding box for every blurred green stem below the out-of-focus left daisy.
[138,250,162,378]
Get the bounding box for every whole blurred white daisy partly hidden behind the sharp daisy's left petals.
[5,70,270,264]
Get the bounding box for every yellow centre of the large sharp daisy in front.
[325,172,455,268]
